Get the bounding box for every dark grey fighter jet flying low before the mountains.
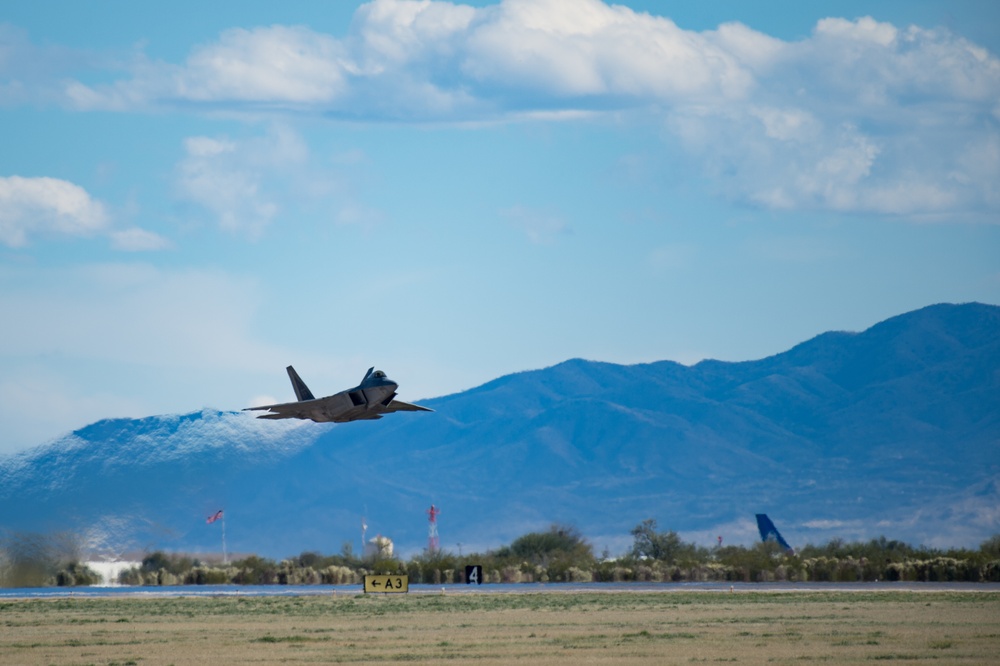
[243,366,434,423]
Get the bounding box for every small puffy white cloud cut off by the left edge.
[0,176,108,247]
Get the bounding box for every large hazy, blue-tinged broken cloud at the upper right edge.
[668,18,1000,217]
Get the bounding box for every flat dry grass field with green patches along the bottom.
[0,591,1000,666]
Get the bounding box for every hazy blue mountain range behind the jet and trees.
[0,303,1000,558]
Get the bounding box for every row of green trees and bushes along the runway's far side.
[0,519,1000,587]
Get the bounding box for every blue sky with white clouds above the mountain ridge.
[0,0,1000,453]
